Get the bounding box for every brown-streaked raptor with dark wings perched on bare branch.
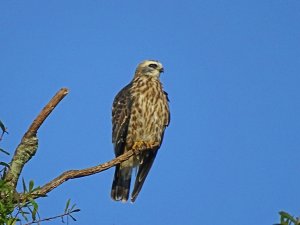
[111,60,170,202]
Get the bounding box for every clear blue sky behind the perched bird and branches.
[0,0,300,225]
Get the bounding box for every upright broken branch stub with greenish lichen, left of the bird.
[5,88,68,188]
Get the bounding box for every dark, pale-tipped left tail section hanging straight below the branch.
[111,165,132,202]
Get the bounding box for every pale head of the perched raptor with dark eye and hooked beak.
[135,60,164,78]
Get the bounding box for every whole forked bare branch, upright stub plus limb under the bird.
[5,88,136,202]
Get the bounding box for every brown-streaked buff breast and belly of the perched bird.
[127,77,168,143]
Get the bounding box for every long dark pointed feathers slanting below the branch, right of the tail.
[131,149,158,202]
